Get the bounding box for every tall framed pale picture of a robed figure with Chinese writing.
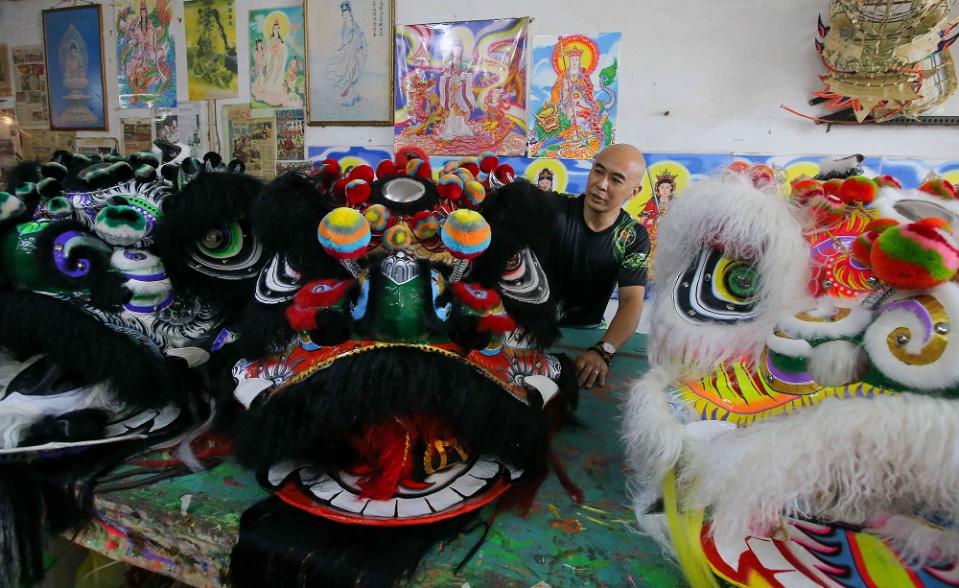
[303,0,396,126]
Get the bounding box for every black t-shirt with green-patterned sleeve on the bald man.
[549,192,649,326]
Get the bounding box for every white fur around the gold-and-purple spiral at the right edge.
[863,282,959,392]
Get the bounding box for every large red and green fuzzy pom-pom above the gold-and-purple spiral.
[869,219,959,290]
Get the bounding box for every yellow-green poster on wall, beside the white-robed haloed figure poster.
[183,0,238,100]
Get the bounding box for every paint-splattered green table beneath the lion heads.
[74,330,683,588]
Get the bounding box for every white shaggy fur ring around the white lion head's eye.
[649,176,809,372]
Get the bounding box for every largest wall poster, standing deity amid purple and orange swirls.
[394,18,528,155]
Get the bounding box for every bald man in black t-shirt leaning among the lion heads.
[550,144,649,388]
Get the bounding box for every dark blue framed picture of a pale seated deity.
[43,4,107,130]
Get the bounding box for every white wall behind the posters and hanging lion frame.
[0,0,959,159]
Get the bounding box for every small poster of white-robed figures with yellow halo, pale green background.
[250,6,306,108]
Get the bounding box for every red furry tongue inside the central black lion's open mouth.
[350,415,464,500]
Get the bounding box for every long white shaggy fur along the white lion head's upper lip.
[680,394,959,561]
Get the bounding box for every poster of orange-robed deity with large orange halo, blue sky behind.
[528,33,621,159]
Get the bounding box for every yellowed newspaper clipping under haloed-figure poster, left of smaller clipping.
[224,105,276,180]
